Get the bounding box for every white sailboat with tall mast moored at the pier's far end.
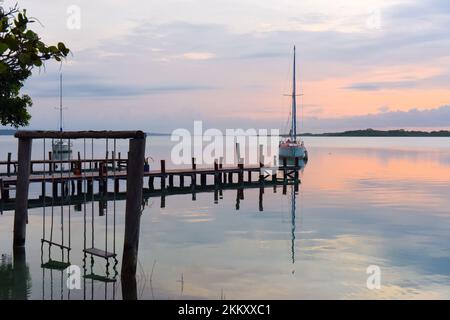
[278,46,308,160]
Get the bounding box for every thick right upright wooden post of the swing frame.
[121,137,145,278]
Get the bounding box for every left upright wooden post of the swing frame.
[14,138,33,247]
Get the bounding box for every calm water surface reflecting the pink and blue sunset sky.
[0,137,450,299]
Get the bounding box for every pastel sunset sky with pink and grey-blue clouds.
[3,0,450,133]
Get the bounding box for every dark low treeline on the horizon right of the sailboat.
[302,129,450,137]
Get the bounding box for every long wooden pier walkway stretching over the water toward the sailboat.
[0,160,301,202]
